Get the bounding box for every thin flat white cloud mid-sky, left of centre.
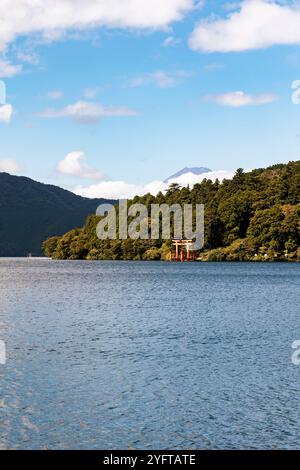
[37,101,138,124]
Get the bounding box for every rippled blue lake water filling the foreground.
[0,259,300,449]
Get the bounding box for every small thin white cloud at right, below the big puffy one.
[203,91,278,108]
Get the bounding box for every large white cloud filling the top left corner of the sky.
[0,0,195,50]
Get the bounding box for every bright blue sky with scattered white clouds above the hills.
[0,0,300,196]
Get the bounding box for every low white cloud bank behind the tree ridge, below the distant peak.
[73,171,234,199]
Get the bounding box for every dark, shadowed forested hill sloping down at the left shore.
[0,173,113,256]
